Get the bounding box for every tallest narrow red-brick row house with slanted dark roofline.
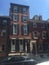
[8,3,31,55]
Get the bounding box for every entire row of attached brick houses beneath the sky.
[0,3,49,56]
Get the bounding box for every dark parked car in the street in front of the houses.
[0,56,36,65]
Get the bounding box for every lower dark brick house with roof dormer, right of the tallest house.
[30,15,49,54]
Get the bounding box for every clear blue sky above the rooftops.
[0,0,49,20]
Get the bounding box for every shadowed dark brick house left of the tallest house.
[0,16,10,57]
